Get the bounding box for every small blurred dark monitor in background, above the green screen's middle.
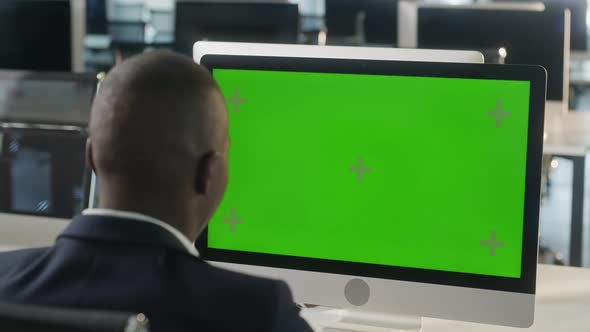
[326,0,398,46]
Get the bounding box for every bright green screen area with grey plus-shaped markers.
[208,69,530,278]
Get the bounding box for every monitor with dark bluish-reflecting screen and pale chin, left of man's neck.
[0,127,89,251]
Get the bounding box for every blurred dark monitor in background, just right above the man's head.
[175,1,299,55]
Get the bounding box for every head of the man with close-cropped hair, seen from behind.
[87,52,228,240]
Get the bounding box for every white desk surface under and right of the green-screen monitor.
[304,265,590,332]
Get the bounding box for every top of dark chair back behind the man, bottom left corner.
[0,303,149,332]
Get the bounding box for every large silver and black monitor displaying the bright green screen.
[198,55,546,327]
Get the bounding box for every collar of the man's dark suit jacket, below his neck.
[58,215,197,258]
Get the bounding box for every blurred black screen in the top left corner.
[0,0,72,71]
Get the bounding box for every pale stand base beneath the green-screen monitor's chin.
[302,307,422,332]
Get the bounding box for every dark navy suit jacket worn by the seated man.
[0,216,311,332]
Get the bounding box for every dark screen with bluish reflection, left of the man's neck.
[0,128,88,218]
